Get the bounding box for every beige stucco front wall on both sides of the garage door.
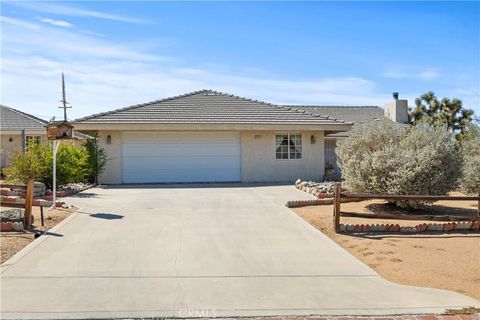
[98,131,324,184]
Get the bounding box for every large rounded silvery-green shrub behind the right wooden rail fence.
[337,120,462,208]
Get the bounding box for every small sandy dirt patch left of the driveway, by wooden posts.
[0,207,75,263]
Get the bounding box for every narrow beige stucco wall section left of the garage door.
[98,131,122,184]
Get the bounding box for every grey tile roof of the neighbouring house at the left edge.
[0,105,47,131]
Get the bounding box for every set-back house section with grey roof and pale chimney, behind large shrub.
[288,93,408,175]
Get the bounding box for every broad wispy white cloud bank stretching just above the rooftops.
[1,19,476,119]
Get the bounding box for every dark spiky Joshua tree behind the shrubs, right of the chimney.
[410,91,473,134]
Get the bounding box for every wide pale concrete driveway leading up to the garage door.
[1,185,478,319]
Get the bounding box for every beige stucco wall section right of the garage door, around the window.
[240,131,325,182]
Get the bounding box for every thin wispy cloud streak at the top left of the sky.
[10,2,149,23]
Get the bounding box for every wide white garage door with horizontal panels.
[122,132,240,183]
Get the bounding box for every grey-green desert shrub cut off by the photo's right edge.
[460,125,480,194]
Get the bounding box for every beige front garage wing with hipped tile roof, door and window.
[73,90,353,184]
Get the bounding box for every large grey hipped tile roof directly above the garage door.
[75,90,350,124]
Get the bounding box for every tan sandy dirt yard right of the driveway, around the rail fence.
[293,196,480,300]
